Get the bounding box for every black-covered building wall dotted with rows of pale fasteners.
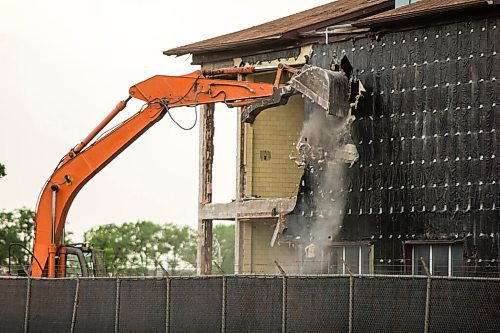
[285,18,500,276]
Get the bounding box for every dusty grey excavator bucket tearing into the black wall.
[290,65,350,118]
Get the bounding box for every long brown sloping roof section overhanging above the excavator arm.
[163,0,394,56]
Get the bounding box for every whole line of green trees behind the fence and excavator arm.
[0,208,234,276]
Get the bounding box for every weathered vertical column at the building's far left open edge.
[196,104,215,275]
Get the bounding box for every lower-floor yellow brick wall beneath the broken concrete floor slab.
[250,219,299,274]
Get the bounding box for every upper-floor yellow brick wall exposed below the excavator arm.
[244,75,304,198]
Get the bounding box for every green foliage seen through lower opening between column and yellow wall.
[213,224,234,274]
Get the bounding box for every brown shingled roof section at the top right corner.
[353,0,498,27]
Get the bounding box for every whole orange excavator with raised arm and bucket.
[31,65,349,278]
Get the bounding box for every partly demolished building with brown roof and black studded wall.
[165,0,500,277]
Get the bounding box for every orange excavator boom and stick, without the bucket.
[32,69,278,278]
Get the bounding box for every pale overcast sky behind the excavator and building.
[0,0,330,240]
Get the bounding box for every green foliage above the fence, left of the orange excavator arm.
[0,208,35,266]
